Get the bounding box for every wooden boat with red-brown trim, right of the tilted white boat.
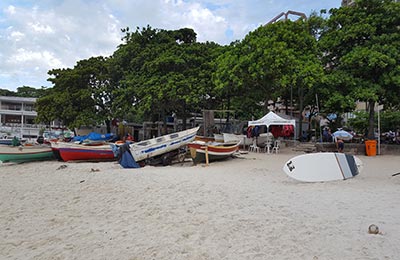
[188,141,239,164]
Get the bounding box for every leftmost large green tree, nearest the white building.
[37,57,114,132]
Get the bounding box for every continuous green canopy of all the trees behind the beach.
[32,0,400,137]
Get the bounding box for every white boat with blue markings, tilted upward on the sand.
[130,127,200,162]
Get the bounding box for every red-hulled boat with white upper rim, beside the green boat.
[51,142,117,162]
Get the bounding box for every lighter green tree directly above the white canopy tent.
[216,20,323,135]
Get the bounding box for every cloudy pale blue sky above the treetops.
[0,0,341,91]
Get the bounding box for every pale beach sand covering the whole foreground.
[0,150,400,260]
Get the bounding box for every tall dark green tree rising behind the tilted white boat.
[113,26,222,130]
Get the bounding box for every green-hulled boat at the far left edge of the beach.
[0,145,54,163]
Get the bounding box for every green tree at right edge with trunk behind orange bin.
[320,0,400,138]
